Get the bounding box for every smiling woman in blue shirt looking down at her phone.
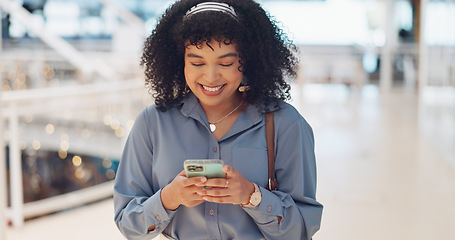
[114,0,322,239]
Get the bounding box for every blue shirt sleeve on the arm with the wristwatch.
[244,117,322,239]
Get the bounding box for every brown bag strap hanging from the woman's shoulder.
[265,112,278,191]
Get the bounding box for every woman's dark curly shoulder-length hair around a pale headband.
[141,0,298,111]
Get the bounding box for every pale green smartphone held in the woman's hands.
[183,159,225,178]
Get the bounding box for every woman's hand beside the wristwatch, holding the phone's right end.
[196,165,254,204]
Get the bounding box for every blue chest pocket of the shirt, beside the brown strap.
[232,147,268,186]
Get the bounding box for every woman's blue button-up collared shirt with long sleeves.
[114,94,322,240]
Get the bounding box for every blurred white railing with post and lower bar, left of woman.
[0,79,151,227]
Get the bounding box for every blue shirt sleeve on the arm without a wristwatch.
[114,110,175,239]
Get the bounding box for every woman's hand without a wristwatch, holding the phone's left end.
[161,171,207,210]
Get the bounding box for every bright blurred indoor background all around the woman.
[0,0,455,240]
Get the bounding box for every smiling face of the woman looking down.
[184,41,243,108]
